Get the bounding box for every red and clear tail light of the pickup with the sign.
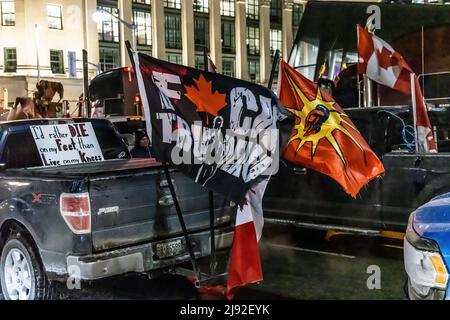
[59,192,91,234]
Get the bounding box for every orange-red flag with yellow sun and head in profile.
[278,60,384,197]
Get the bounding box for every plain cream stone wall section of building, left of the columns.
[0,0,99,103]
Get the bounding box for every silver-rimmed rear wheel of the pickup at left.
[0,233,48,300]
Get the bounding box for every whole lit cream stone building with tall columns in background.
[0,0,304,103]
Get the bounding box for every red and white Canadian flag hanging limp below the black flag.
[227,179,269,299]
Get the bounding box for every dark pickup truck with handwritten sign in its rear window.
[0,119,233,299]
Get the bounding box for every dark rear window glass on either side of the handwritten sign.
[2,126,130,168]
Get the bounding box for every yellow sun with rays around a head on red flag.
[286,75,364,165]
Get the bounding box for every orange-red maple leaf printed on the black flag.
[184,74,227,116]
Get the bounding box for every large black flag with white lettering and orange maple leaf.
[133,53,285,204]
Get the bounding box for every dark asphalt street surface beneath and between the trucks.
[11,227,406,300]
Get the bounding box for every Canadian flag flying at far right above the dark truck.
[358,26,437,152]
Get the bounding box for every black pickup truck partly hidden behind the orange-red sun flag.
[263,106,450,235]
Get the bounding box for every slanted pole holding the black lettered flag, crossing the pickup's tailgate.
[125,40,201,287]
